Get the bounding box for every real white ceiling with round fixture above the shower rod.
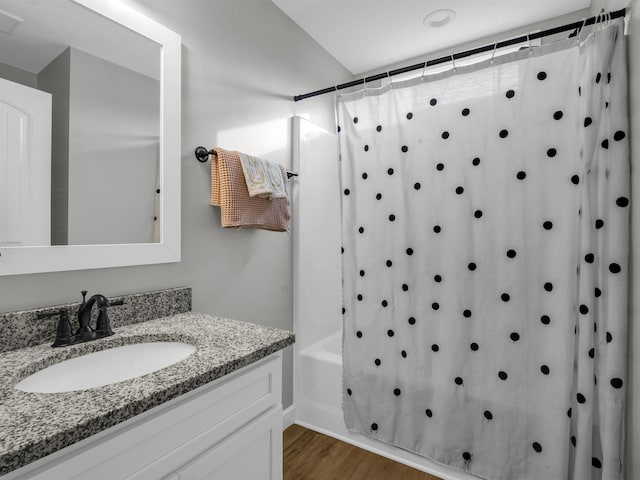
[272,0,591,75]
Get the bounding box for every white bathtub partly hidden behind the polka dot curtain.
[295,331,478,480]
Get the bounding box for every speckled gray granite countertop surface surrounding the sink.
[0,313,294,475]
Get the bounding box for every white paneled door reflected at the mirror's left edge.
[0,78,51,246]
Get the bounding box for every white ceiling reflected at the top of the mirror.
[0,0,160,79]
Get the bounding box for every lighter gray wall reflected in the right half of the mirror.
[68,48,160,245]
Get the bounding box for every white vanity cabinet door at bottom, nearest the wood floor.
[178,407,282,480]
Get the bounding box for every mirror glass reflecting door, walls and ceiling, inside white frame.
[0,0,161,247]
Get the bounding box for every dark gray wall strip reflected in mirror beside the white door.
[38,48,71,245]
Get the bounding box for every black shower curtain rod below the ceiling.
[293,8,626,102]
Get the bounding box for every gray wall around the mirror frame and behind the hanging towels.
[0,0,351,407]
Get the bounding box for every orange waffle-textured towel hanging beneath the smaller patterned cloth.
[211,147,291,232]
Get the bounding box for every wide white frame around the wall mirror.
[0,0,182,276]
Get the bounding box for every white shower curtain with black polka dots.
[337,19,629,480]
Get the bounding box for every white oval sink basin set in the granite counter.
[15,342,196,393]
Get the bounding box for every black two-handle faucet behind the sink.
[38,290,124,347]
